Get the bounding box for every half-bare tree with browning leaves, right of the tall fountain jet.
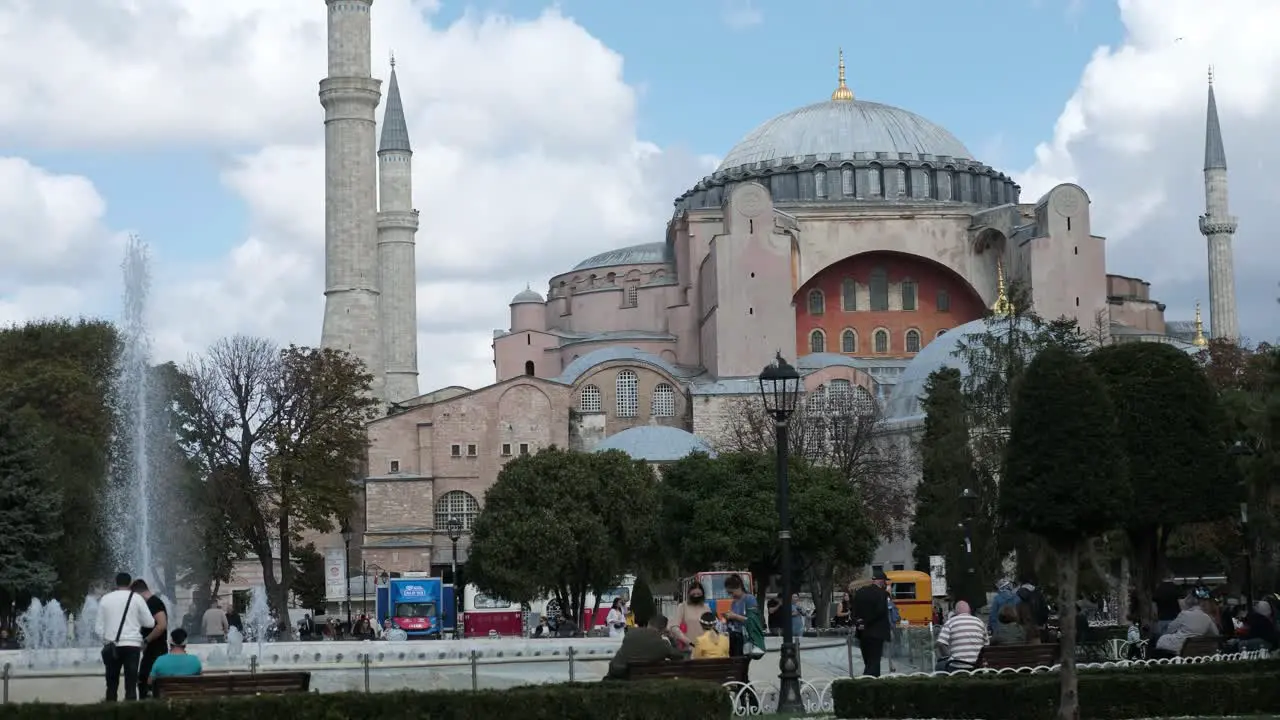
[186,336,378,627]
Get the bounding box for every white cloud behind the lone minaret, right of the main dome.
[1018,0,1280,341]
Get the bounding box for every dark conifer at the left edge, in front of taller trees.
[0,405,63,597]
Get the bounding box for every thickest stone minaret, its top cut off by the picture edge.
[320,0,385,398]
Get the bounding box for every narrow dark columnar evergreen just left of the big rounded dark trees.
[911,368,983,607]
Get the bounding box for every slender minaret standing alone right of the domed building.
[1199,68,1240,341]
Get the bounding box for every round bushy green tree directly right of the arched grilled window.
[467,447,657,619]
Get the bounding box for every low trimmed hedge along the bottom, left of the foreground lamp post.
[4,680,732,720]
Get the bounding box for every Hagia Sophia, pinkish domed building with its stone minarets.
[302,0,1238,589]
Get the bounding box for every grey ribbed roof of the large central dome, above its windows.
[718,99,974,170]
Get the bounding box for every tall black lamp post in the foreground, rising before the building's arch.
[760,352,804,712]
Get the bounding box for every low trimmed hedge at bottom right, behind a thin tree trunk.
[832,660,1280,720]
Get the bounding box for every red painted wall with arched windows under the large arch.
[795,252,987,357]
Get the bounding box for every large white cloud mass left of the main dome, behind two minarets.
[0,0,714,391]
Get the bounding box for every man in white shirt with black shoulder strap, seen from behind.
[95,573,156,702]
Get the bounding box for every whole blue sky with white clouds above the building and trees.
[0,0,1280,389]
